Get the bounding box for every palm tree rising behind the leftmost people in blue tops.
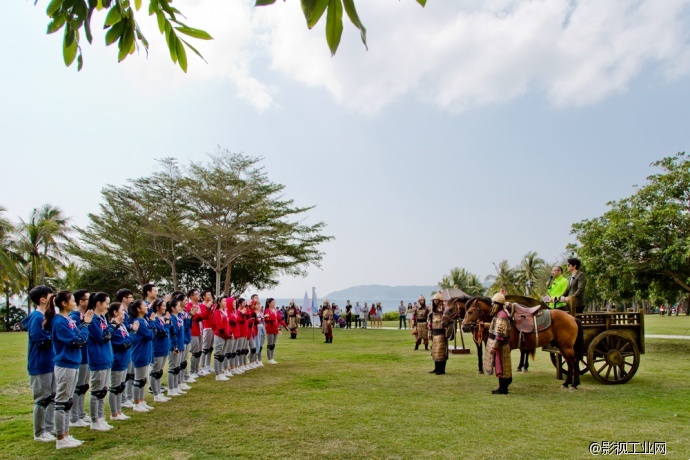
[17,204,69,310]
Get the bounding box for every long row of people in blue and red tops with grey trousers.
[24,285,285,449]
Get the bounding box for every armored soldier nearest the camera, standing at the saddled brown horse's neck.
[484,292,513,395]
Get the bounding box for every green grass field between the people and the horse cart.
[0,324,690,460]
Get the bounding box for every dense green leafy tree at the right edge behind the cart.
[573,152,690,310]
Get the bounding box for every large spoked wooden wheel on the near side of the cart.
[587,331,640,385]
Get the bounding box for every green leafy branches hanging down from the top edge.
[36,0,426,72]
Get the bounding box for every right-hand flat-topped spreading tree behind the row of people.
[168,150,332,294]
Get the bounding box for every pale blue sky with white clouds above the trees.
[0,0,690,298]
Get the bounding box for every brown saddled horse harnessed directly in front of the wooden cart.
[462,298,583,390]
